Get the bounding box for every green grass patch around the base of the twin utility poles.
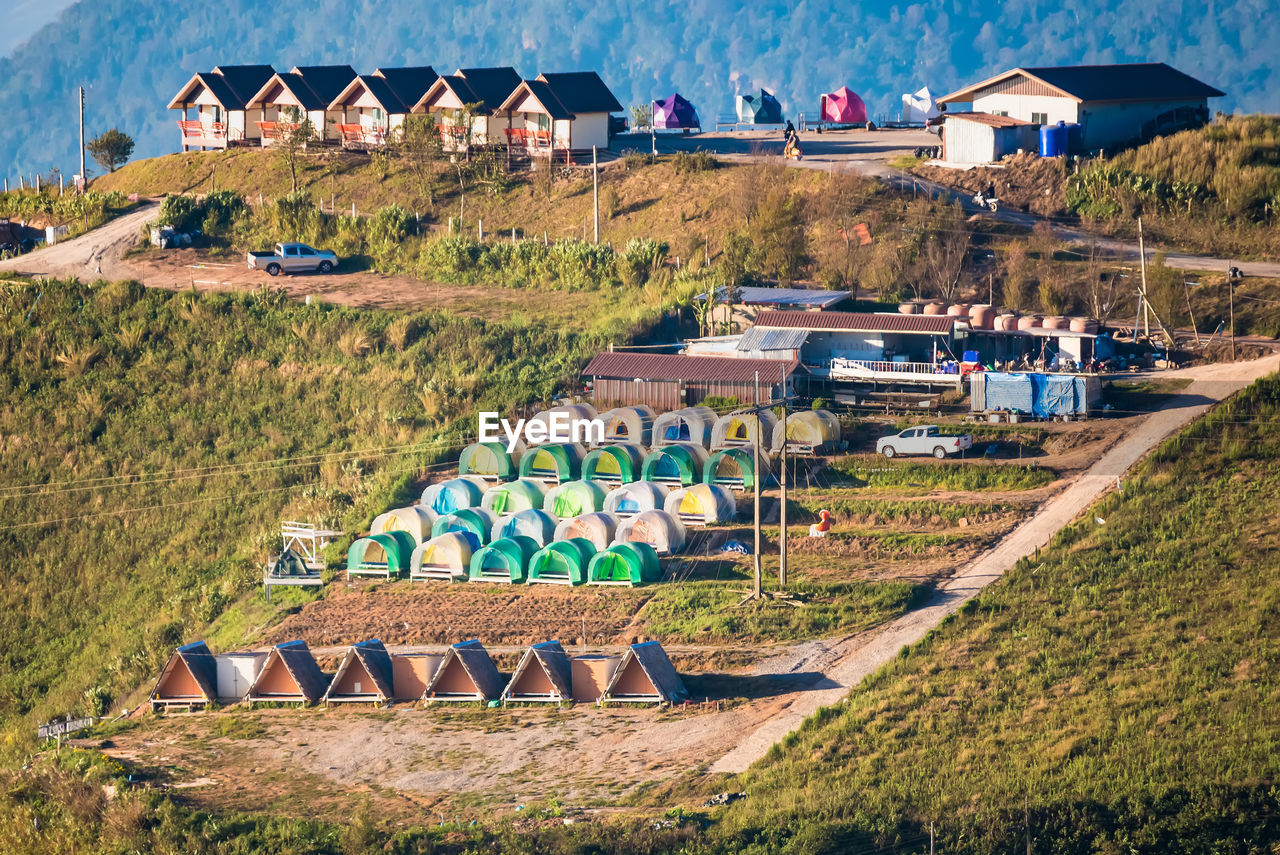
[639,577,924,643]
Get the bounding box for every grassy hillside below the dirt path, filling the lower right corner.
[722,378,1280,852]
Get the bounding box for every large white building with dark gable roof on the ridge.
[938,63,1224,151]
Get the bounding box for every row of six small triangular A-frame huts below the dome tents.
[150,639,689,710]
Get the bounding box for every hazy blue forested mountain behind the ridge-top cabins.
[0,0,1280,180]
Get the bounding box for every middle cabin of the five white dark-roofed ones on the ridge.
[329,65,440,148]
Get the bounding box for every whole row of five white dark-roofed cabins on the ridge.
[169,65,622,152]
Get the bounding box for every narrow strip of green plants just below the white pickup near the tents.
[831,457,1057,493]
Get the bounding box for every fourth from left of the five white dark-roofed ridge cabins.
[412,65,520,150]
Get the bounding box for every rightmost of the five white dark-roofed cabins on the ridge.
[499,72,622,154]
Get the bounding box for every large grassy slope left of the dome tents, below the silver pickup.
[0,282,646,747]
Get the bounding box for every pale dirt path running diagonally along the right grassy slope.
[710,356,1280,772]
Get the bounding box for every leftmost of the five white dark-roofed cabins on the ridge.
[169,65,275,151]
